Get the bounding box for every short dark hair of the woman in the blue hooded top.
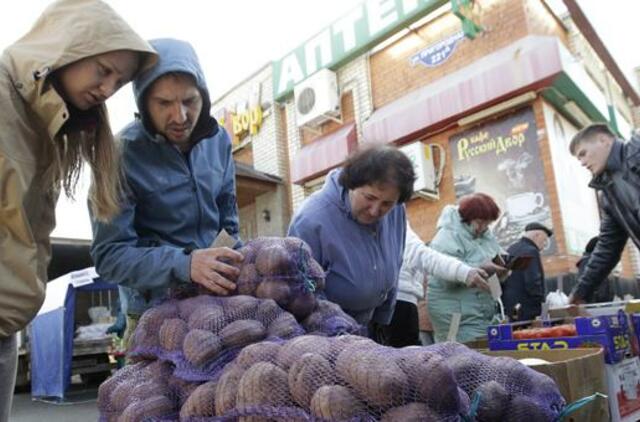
[338,145,416,204]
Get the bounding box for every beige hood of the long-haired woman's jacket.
[2,0,157,138]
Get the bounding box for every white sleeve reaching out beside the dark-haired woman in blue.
[404,224,472,283]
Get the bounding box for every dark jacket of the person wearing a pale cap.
[502,237,545,321]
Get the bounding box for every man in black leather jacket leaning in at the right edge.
[569,123,640,304]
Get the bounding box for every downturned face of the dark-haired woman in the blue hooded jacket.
[349,183,400,225]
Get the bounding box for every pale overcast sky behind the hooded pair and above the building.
[0,0,640,237]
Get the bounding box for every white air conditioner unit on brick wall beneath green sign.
[293,69,340,127]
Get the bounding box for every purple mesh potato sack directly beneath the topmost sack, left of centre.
[128,295,304,381]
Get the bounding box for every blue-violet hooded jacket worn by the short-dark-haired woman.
[289,170,407,324]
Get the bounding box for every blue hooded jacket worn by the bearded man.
[91,39,238,315]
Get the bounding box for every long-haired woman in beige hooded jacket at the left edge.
[0,0,157,416]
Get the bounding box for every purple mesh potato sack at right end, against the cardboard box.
[427,343,566,422]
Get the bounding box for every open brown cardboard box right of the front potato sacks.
[483,348,609,422]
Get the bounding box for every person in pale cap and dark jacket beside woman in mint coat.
[502,223,553,321]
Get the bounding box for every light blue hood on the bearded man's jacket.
[133,38,218,142]
